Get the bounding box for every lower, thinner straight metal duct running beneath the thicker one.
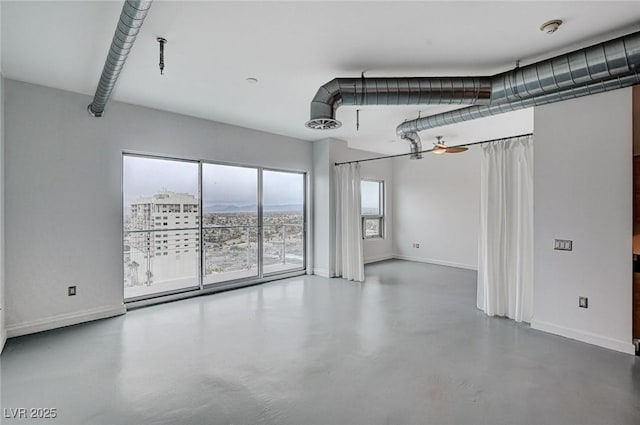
[396,71,640,134]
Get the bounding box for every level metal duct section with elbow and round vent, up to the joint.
[305,77,491,130]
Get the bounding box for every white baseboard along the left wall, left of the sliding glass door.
[7,304,127,338]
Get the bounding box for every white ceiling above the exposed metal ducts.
[2,0,640,153]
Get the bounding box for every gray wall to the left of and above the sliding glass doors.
[5,80,312,336]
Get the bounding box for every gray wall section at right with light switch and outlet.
[531,88,634,353]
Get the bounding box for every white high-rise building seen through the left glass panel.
[124,190,200,289]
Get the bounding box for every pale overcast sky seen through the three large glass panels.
[124,155,304,212]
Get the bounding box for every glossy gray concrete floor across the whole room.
[1,261,640,425]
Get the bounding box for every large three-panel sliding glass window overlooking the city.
[123,154,306,301]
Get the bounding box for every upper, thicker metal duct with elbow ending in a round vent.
[306,32,640,131]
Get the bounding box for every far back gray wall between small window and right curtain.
[393,147,482,269]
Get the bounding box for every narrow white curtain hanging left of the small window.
[335,164,364,282]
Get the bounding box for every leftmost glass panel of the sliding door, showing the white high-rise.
[123,156,200,299]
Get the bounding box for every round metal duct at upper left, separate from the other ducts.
[87,0,153,117]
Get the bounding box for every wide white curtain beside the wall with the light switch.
[477,137,533,322]
